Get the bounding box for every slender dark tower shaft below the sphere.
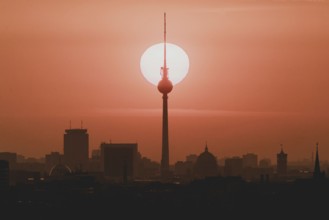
[161,93,169,177]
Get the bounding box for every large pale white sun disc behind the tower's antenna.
[140,43,190,85]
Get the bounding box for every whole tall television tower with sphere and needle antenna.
[158,13,173,178]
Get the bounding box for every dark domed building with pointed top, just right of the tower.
[194,144,219,178]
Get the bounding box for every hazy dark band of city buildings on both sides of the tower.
[0,124,329,182]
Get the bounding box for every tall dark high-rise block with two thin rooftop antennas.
[64,128,89,172]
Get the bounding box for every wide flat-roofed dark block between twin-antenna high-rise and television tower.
[100,143,138,182]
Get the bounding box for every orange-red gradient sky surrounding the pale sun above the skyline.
[0,0,329,164]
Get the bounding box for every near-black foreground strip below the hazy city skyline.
[0,177,329,219]
